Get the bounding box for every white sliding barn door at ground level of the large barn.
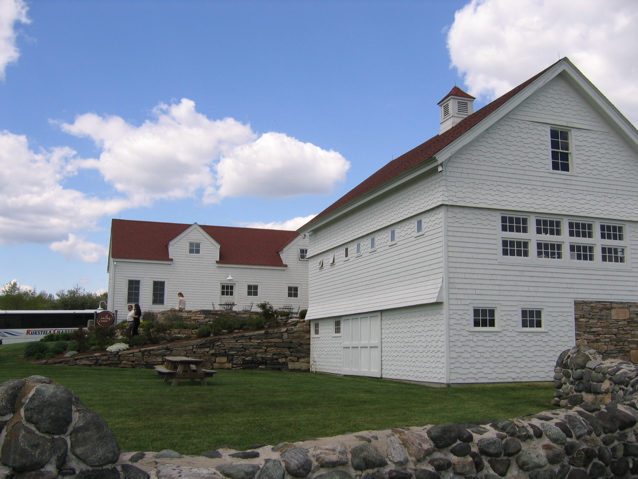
[342,313,381,378]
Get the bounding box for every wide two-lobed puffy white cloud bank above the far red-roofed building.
[61,99,350,206]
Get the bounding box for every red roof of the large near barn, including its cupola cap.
[302,60,562,228]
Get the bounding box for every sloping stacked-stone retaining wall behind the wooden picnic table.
[40,320,310,371]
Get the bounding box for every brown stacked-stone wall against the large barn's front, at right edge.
[574,301,638,362]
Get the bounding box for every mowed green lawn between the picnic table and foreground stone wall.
[0,344,553,454]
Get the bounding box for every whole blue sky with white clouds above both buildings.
[0,0,638,293]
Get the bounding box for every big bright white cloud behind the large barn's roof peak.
[448,0,638,124]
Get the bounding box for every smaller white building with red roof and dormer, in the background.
[108,219,308,320]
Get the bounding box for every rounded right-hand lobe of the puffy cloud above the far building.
[217,132,350,202]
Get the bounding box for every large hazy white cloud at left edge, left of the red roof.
[0,131,128,248]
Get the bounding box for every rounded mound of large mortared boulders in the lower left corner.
[0,376,150,479]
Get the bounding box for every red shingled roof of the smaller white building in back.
[111,219,299,266]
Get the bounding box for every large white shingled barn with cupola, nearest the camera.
[299,58,638,384]
